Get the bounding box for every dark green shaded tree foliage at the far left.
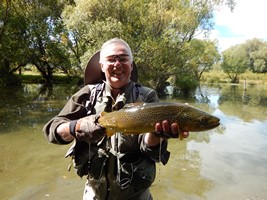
[0,0,71,84]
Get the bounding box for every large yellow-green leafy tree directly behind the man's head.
[62,0,234,93]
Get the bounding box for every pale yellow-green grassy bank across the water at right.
[201,70,267,85]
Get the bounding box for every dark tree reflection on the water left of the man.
[0,84,77,133]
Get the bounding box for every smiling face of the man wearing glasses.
[101,44,133,89]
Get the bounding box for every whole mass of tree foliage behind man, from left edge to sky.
[0,0,235,92]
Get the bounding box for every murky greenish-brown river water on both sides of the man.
[0,85,267,200]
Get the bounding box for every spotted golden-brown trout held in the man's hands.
[98,102,220,136]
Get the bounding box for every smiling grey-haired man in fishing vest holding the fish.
[44,38,188,200]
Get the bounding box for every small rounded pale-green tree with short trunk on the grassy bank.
[221,44,250,83]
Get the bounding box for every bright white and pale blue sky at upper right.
[210,0,267,51]
